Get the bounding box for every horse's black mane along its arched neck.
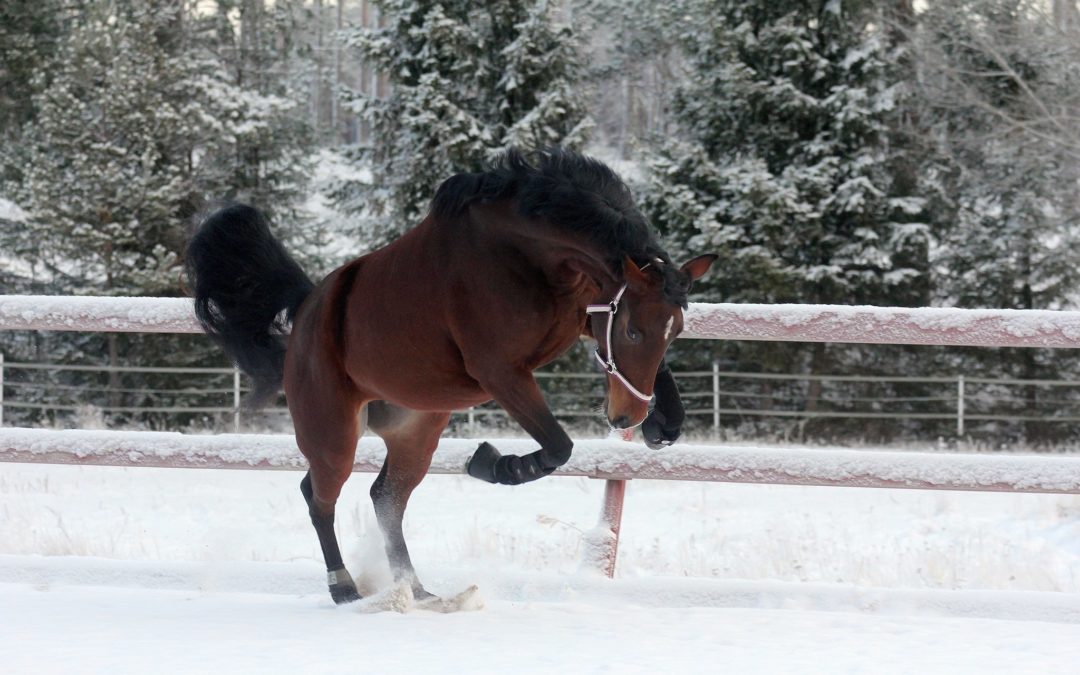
[431,148,690,307]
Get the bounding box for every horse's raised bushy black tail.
[186,204,314,409]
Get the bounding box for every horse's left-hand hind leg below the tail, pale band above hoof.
[293,397,363,605]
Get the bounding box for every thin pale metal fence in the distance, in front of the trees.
[0,354,1080,435]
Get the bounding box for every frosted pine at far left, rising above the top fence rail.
[12,3,186,294]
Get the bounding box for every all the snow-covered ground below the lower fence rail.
[0,457,1080,673]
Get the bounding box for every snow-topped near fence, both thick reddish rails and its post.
[6,296,1080,576]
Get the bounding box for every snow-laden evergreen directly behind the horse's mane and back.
[339,0,590,246]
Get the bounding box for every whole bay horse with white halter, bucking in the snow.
[185,148,717,604]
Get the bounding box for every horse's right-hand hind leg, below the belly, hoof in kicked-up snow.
[368,402,450,599]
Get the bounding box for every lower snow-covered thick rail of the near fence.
[0,428,1080,495]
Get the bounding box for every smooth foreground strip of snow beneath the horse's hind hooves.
[8,574,1080,674]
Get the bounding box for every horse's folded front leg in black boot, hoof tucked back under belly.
[465,373,573,485]
